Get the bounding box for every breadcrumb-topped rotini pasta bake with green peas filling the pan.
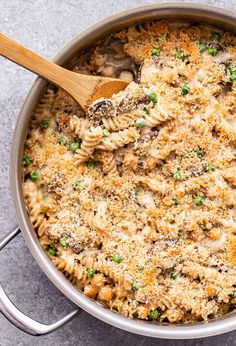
[22,21,236,323]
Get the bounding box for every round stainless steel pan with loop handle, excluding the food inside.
[0,2,236,339]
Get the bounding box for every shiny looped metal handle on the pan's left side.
[0,227,82,336]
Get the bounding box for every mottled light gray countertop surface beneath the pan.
[0,0,236,346]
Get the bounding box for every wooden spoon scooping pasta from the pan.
[0,33,129,109]
